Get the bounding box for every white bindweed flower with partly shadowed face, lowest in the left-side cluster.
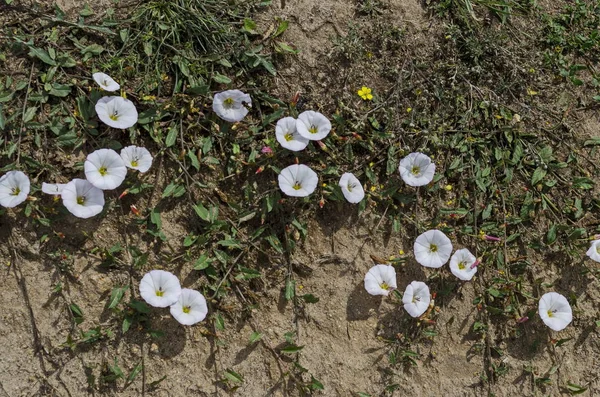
[60,179,104,219]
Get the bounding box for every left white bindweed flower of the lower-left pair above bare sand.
[140,270,181,307]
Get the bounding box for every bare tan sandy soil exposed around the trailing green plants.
[0,0,600,397]
